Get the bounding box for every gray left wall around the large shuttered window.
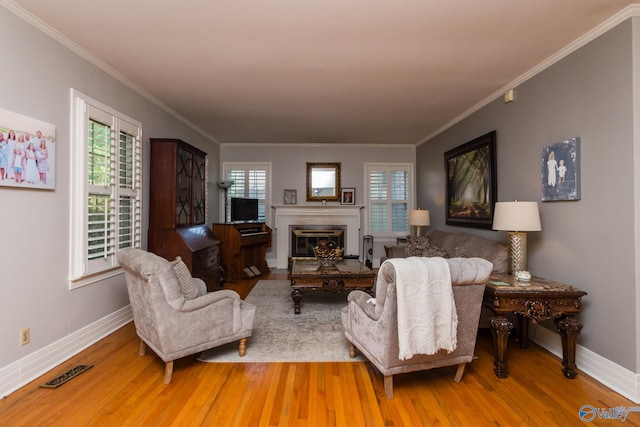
[0,8,219,368]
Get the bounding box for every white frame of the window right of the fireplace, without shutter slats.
[364,163,416,239]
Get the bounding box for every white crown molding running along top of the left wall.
[0,0,220,145]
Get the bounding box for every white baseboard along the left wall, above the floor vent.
[0,306,133,396]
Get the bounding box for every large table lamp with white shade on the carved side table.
[493,200,542,275]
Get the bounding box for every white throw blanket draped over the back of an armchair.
[387,257,458,360]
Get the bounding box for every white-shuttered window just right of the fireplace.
[365,164,413,236]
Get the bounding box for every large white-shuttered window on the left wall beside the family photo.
[70,90,142,287]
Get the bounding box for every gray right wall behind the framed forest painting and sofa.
[416,18,640,372]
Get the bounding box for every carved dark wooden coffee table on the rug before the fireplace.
[289,259,376,314]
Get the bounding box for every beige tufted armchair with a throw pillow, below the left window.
[118,249,255,384]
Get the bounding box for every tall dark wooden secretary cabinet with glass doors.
[149,138,220,291]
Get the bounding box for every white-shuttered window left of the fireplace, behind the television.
[222,163,271,222]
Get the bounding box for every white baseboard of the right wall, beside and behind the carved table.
[528,326,640,404]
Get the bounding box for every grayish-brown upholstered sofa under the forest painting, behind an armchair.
[380,229,508,273]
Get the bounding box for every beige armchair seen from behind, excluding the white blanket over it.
[342,257,493,399]
